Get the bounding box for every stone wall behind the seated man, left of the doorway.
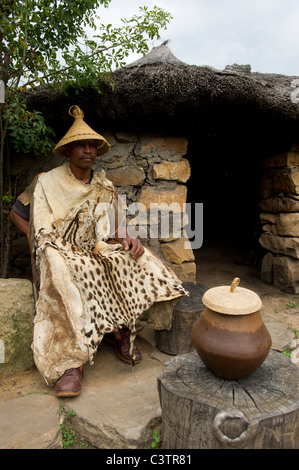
[12,132,196,282]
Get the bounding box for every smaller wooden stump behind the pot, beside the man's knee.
[155,282,209,356]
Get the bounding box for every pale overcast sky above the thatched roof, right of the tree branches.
[95,0,299,76]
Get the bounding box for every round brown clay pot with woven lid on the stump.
[192,278,272,380]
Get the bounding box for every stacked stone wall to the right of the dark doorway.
[259,144,299,294]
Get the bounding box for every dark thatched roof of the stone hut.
[29,44,299,146]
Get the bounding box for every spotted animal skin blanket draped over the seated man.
[19,163,188,385]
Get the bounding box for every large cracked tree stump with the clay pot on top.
[158,350,299,449]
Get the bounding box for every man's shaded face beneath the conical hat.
[68,139,98,170]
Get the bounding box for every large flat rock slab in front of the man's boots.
[60,339,170,449]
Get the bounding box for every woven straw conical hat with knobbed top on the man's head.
[53,105,110,156]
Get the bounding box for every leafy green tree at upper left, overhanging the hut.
[0,0,171,162]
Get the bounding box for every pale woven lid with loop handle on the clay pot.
[202,277,262,315]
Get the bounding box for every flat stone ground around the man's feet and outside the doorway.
[0,242,299,449]
